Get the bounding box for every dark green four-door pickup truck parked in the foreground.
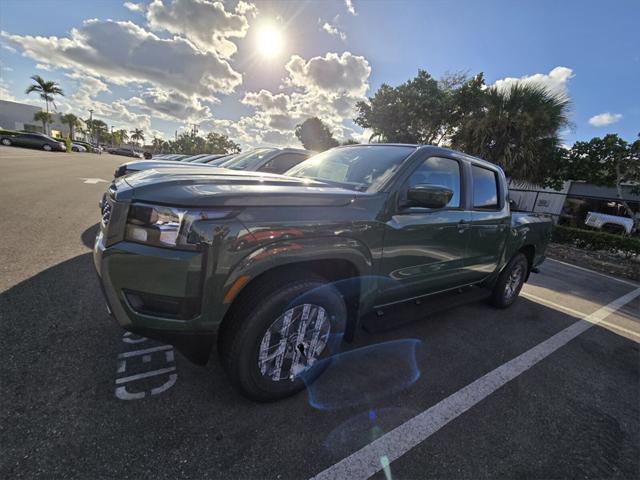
[94,144,551,401]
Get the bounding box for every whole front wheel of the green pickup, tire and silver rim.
[218,272,347,402]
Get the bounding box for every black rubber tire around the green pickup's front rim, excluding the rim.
[218,271,347,402]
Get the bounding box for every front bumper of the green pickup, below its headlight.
[93,219,215,363]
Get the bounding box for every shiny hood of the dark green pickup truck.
[117,166,363,207]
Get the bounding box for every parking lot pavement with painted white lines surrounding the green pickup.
[0,147,640,479]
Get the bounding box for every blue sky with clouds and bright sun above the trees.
[0,0,640,146]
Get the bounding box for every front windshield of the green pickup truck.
[285,145,416,191]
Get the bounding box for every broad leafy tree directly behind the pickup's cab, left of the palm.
[354,70,484,144]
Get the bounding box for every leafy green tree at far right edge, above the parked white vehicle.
[556,134,640,226]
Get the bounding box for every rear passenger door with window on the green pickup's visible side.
[467,165,511,281]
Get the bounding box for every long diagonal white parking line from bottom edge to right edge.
[313,288,640,480]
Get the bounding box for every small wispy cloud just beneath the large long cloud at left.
[127,88,211,122]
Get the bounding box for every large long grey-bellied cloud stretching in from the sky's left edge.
[1,20,242,99]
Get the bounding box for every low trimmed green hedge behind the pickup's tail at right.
[551,225,640,257]
